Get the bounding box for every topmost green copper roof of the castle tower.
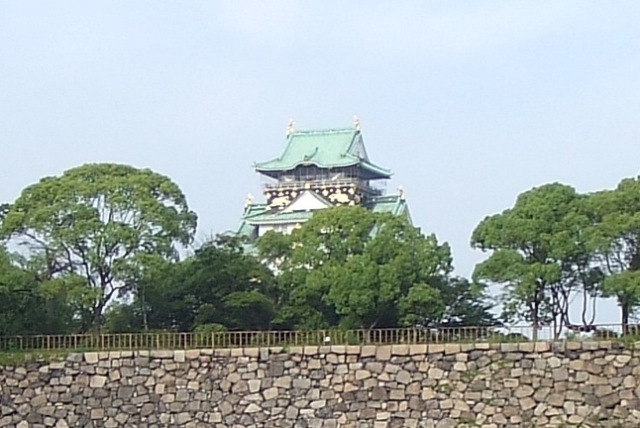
[255,128,391,178]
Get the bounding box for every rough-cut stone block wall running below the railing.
[0,342,640,428]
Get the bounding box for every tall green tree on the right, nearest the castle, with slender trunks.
[471,183,592,338]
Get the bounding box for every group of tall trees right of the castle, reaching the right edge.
[471,178,640,336]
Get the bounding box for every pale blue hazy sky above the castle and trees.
[0,0,640,319]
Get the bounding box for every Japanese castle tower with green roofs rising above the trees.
[239,119,411,241]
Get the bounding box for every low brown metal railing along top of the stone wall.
[0,324,640,352]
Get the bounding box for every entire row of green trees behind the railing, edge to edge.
[0,164,640,336]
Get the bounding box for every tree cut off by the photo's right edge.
[589,178,640,331]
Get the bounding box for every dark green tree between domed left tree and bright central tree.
[139,235,275,331]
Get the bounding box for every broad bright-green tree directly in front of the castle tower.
[258,207,452,329]
